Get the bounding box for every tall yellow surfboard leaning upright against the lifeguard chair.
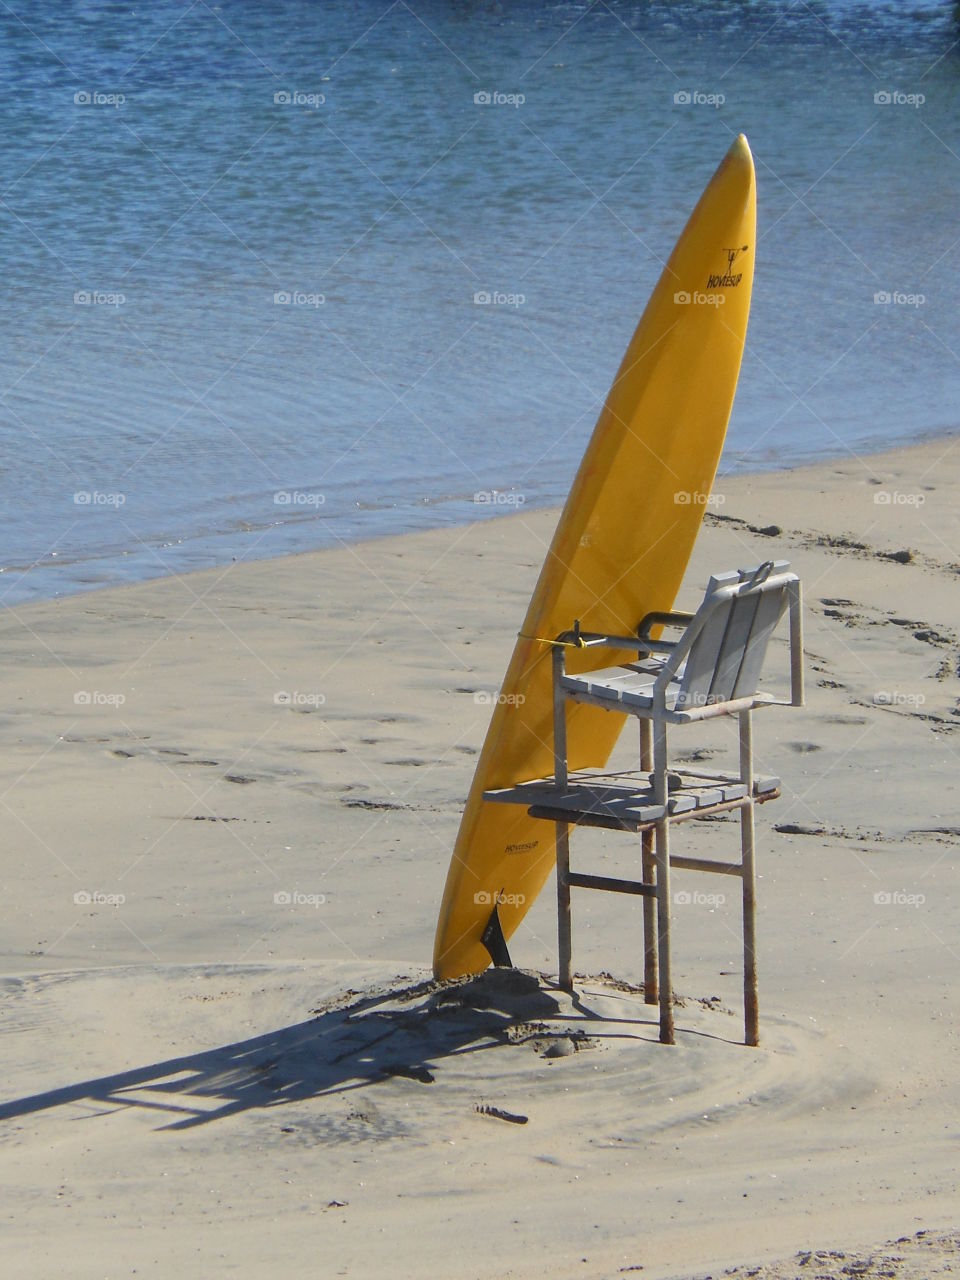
[434,134,756,978]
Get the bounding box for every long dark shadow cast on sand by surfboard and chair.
[0,969,665,1129]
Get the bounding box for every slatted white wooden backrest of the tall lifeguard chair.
[671,561,799,710]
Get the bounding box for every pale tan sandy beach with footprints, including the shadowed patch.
[0,440,960,1280]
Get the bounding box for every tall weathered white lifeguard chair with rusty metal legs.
[485,561,804,1044]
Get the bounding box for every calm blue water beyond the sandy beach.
[0,0,960,604]
